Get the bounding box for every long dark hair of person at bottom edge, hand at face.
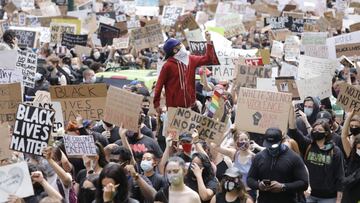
[96,163,129,203]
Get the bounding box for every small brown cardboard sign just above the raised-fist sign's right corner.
[275,76,300,100]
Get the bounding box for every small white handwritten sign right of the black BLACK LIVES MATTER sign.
[64,135,97,157]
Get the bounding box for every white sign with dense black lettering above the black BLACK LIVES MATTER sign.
[16,50,37,88]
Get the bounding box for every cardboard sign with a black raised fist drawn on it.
[235,88,292,134]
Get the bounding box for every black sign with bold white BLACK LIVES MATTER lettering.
[10,104,55,155]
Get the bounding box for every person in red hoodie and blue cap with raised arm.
[154,32,217,115]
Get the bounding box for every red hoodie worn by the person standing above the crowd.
[154,44,217,108]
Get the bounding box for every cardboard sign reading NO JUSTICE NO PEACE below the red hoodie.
[168,108,226,144]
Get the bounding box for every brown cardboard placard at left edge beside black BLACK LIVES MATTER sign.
[0,83,22,125]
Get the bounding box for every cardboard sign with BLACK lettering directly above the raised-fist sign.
[236,65,271,88]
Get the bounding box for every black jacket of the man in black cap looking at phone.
[247,145,309,203]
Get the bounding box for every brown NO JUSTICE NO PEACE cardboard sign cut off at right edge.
[336,82,360,115]
